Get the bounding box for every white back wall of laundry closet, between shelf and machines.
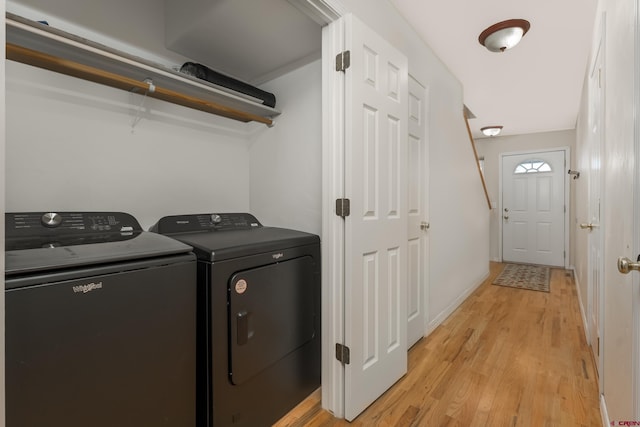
[5,61,254,228]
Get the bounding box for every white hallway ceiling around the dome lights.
[390,0,597,138]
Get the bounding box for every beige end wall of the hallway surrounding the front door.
[476,130,585,262]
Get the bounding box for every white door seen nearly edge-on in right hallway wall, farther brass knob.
[580,36,604,387]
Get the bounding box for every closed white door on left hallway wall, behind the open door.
[407,76,429,347]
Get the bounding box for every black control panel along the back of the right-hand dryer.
[149,213,262,234]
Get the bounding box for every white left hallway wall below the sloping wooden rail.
[429,74,490,328]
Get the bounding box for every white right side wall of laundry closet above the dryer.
[249,61,322,234]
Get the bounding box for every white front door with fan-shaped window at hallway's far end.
[500,150,566,266]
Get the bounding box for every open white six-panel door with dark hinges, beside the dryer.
[345,15,408,420]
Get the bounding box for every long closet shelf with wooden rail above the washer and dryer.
[6,13,280,126]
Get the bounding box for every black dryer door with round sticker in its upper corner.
[228,256,319,385]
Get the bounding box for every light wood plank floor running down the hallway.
[275,263,602,427]
